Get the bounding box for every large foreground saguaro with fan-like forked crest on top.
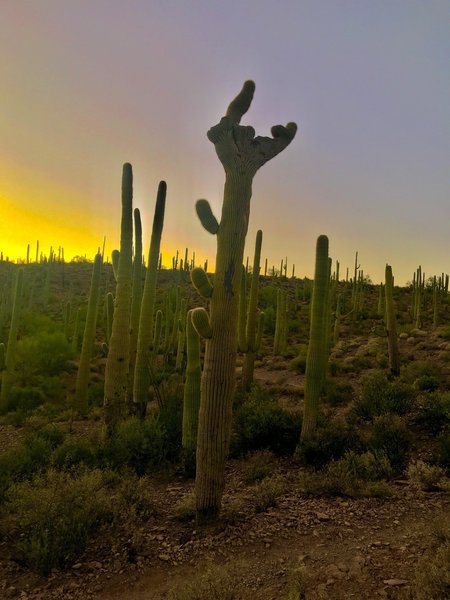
[194,81,297,519]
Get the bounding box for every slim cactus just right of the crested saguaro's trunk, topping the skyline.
[242,229,262,390]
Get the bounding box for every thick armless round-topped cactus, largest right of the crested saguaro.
[301,235,330,441]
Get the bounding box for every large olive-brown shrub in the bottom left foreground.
[3,470,110,575]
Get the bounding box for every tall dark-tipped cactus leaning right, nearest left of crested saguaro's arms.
[133,181,167,418]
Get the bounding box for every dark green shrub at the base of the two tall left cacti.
[100,414,167,475]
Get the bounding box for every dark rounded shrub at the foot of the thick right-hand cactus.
[296,421,359,469]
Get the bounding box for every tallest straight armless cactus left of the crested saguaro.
[103,163,133,436]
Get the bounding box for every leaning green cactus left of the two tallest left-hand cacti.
[74,254,102,416]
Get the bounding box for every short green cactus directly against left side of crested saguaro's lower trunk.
[182,310,202,471]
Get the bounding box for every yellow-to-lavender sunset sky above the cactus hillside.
[0,0,450,285]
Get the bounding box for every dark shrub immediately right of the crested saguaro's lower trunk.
[232,387,300,455]
